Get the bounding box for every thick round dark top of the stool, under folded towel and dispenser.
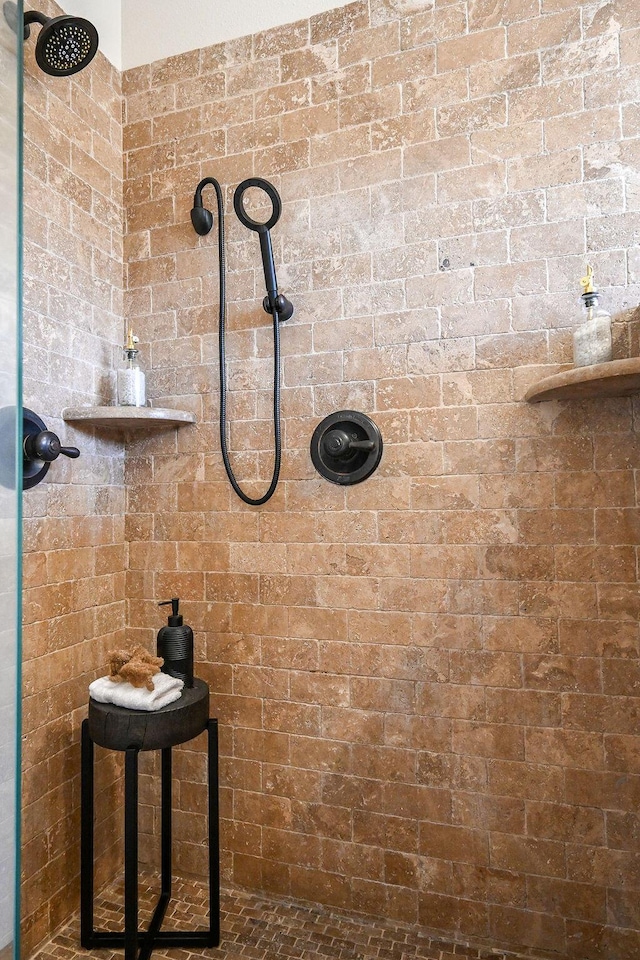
[89,680,209,750]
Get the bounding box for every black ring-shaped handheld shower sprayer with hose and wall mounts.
[191,177,293,507]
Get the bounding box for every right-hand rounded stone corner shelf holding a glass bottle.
[524,357,640,403]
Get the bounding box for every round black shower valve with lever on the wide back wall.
[311,410,383,486]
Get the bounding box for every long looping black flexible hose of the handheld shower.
[212,178,282,507]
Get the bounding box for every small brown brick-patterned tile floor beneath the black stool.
[33,880,544,960]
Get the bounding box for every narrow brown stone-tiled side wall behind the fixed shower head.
[22,3,126,955]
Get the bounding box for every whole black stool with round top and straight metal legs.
[80,680,220,960]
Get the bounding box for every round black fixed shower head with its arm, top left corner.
[3,0,98,77]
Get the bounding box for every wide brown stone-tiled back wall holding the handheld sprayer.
[123,0,640,960]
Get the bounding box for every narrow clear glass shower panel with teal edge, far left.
[0,0,22,960]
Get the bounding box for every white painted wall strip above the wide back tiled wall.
[119,0,350,70]
